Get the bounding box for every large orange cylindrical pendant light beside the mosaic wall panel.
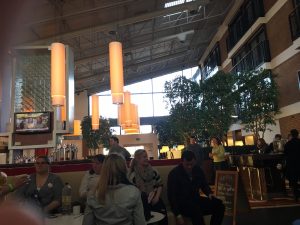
[51,43,66,106]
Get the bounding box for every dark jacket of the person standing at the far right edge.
[284,138,300,179]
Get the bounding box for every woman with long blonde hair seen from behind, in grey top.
[82,154,146,225]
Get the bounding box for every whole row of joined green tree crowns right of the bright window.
[156,70,279,146]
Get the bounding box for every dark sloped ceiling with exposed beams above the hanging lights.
[9,0,234,94]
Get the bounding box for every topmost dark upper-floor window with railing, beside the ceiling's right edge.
[227,0,264,51]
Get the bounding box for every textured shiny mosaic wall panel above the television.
[14,51,52,112]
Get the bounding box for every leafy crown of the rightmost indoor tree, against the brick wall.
[237,70,279,138]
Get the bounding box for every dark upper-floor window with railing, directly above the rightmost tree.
[232,27,270,73]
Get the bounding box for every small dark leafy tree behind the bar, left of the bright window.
[81,116,111,149]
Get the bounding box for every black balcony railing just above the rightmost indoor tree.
[231,40,270,73]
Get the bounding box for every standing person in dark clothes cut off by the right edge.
[284,129,300,201]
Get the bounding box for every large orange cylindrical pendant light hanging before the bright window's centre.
[109,41,124,104]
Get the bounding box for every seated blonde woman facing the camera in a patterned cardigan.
[128,149,168,224]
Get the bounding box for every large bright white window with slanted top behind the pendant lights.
[90,67,200,134]
